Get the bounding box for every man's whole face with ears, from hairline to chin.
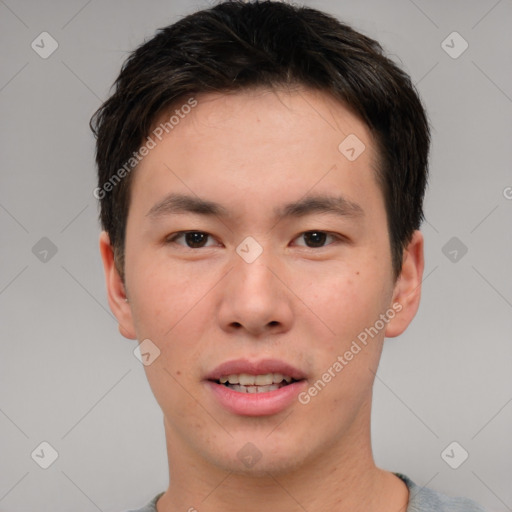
[102,90,423,472]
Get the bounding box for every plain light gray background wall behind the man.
[0,0,512,512]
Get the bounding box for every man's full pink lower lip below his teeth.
[206,380,307,416]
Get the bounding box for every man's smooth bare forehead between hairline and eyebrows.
[132,88,377,221]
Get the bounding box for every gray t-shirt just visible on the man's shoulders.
[128,473,485,512]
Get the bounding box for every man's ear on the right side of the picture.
[385,230,425,338]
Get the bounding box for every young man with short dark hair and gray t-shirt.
[92,1,482,512]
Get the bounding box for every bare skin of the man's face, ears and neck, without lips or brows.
[100,89,424,512]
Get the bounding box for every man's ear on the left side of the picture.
[100,231,137,340]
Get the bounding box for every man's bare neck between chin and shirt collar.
[157,402,408,512]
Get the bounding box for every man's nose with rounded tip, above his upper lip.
[218,249,293,337]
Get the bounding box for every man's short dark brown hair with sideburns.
[90,0,430,277]
